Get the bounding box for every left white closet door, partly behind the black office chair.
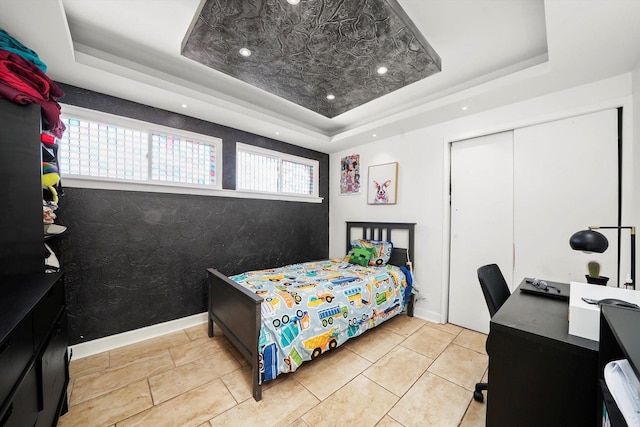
[449,132,513,333]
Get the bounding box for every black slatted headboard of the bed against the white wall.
[347,221,416,266]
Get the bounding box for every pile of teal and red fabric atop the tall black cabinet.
[0,29,65,138]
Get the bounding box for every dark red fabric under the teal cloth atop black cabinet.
[0,49,65,138]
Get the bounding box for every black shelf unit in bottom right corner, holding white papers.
[598,305,640,427]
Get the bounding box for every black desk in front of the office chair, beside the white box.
[487,281,600,427]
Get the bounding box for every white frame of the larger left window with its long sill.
[60,103,324,203]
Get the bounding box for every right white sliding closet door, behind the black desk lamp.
[513,109,624,286]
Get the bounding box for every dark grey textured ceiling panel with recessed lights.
[182,0,441,117]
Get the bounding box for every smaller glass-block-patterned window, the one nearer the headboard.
[236,143,319,197]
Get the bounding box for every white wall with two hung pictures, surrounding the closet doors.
[329,70,640,322]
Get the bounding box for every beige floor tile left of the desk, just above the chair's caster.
[428,344,488,396]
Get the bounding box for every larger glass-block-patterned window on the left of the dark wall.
[58,109,222,188]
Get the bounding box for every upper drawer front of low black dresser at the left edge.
[0,314,33,404]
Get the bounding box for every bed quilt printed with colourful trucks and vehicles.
[230,260,411,382]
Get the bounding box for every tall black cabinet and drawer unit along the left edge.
[0,99,69,427]
